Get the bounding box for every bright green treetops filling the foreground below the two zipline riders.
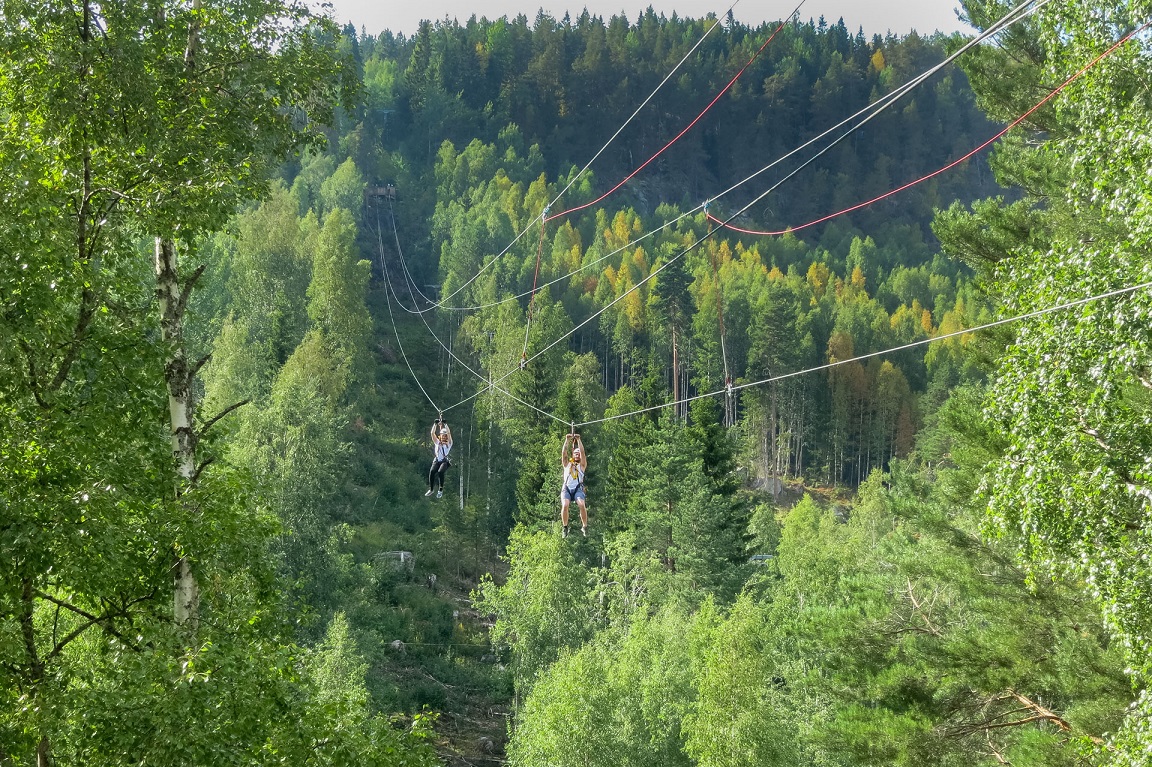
[485,449,1130,765]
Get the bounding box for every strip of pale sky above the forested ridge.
[328,0,972,37]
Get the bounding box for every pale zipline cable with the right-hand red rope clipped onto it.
[425,0,1052,311]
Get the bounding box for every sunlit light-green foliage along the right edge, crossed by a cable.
[938,3,1152,750]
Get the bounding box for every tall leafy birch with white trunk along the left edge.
[0,0,350,767]
